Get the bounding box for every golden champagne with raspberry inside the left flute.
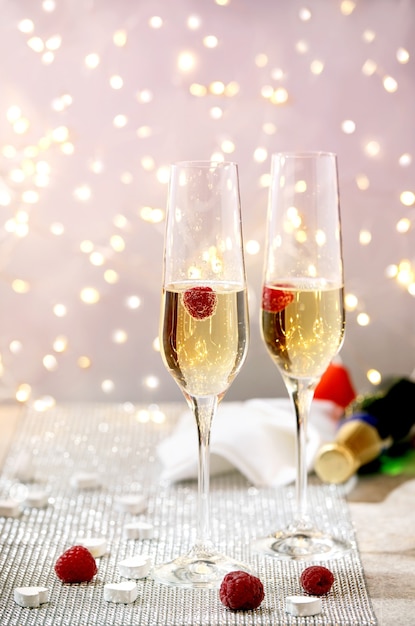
[160,284,248,397]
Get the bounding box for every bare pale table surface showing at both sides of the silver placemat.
[0,405,415,626]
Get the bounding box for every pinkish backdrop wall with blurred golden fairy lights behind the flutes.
[0,0,415,406]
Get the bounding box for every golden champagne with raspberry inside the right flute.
[261,281,345,378]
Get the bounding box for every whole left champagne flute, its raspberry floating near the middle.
[153,161,249,587]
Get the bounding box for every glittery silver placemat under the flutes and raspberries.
[0,404,376,626]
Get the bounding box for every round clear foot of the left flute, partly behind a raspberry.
[152,550,252,589]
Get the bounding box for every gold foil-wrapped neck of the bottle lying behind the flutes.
[314,419,385,484]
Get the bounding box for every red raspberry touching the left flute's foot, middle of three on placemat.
[219,571,265,611]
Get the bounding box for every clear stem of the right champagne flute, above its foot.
[286,379,316,529]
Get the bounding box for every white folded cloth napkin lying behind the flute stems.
[157,398,338,486]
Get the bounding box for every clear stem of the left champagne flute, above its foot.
[192,396,218,550]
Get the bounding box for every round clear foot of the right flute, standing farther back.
[251,529,351,561]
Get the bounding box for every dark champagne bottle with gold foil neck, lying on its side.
[314,378,415,483]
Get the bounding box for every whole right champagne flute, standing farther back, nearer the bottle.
[253,152,348,560]
